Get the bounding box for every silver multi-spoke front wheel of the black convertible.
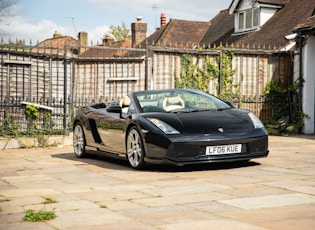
[126,127,145,169]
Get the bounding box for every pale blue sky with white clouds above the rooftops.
[1,0,232,44]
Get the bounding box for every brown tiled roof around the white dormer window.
[200,0,315,49]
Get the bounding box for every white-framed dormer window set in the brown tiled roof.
[237,8,260,32]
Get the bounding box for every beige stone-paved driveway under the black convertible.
[0,136,315,230]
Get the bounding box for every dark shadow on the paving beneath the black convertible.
[52,153,260,173]
